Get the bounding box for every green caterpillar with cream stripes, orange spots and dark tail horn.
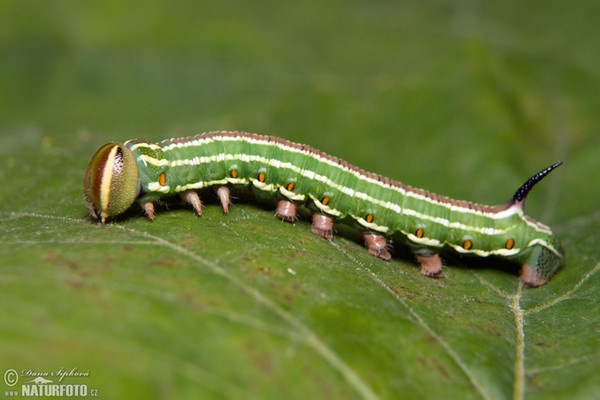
[83,132,563,287]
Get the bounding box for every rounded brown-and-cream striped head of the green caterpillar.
[83,142,141,224]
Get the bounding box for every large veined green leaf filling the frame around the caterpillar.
[0,1,600,399]
